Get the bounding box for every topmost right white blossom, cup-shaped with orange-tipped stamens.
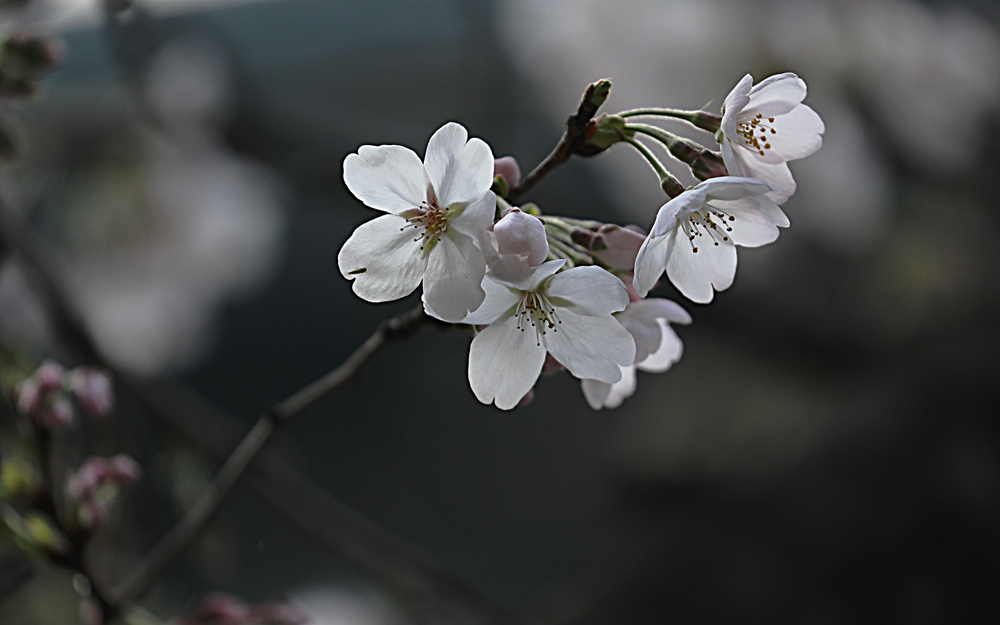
[717,73,825,204]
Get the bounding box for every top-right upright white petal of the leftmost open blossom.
[424,122,493,207]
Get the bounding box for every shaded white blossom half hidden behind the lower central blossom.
[580,298,691,410]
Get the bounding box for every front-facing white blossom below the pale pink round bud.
[464,260,635,410]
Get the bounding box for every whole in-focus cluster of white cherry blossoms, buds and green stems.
[338,73,824,409]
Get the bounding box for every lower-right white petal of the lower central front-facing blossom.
[542,308,635,382]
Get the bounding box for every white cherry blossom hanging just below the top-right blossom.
[634,176,788,304]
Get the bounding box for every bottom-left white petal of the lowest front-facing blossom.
[469,316,545,410]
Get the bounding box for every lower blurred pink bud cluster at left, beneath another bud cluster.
[66,454,142,529]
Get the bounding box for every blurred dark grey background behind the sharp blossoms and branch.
[0,0,1000,625]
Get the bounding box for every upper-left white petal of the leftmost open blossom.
[344,145,430,213]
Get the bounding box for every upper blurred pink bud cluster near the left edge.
[15,360,114,430]
